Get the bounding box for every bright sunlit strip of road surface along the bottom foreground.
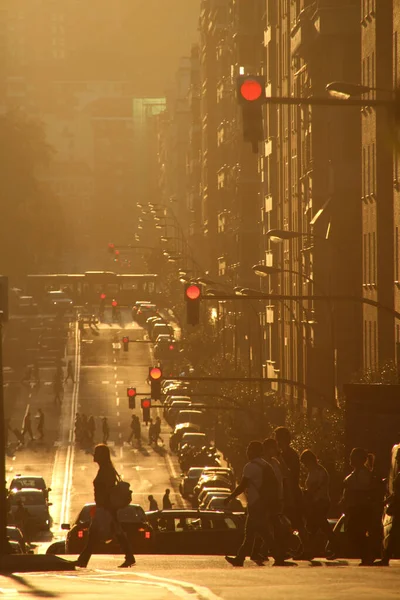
[0,555,400,600]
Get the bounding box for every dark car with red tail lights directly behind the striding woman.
[61,503,153,554]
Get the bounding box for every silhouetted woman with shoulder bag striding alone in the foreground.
[75,444,136,569]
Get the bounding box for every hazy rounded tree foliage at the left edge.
[0,111,62,278]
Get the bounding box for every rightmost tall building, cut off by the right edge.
[361,0,400,370]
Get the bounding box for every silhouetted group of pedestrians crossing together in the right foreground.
[225,427,400,566]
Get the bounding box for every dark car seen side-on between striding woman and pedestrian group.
[146,509,244,555]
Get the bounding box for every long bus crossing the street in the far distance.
[26,271,158,306]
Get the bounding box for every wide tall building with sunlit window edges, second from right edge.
[260,0,361,405]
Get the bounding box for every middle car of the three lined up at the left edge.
[8,488,52,533]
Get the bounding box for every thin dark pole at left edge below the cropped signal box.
[0,311,10,555]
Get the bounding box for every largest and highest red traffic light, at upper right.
[236,75,265,153]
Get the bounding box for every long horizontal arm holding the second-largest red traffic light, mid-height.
[201,293,400,319]
